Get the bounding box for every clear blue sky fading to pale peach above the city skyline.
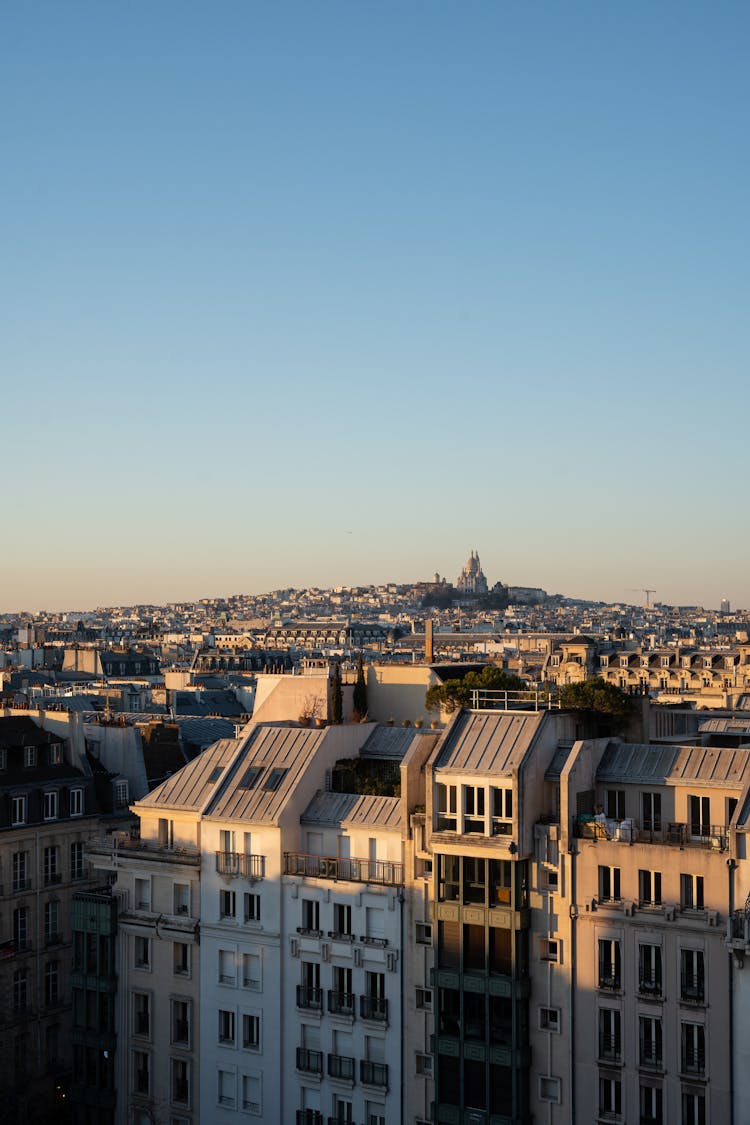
[0,0,750,610]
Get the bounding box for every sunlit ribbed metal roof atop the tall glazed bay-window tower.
[435,711,544,777]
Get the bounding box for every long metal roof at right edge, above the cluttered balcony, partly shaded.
[596,743,750,789]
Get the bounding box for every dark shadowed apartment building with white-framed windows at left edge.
[0,710,99,1122]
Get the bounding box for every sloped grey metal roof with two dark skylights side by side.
[206,725,326,825]
